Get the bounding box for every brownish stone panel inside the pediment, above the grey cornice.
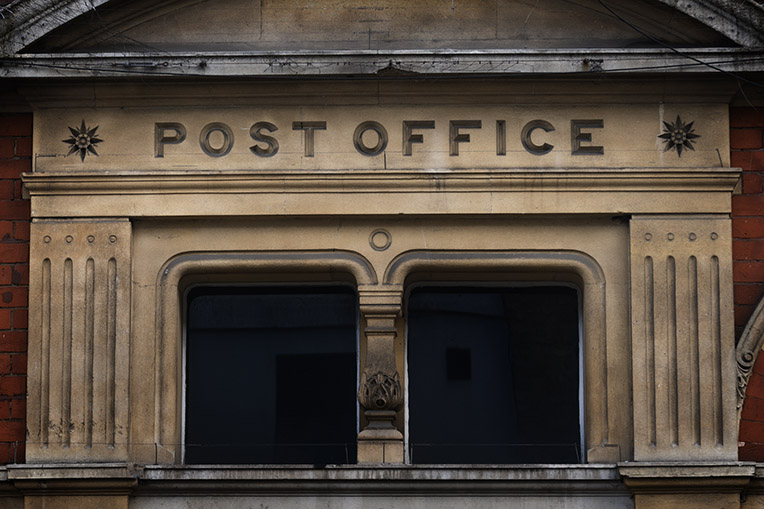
[17,0,738,53]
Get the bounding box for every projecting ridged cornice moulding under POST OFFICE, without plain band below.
[22,168,740,197]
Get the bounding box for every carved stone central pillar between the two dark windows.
[358,290,403,463]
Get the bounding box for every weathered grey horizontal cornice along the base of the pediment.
[0,48,764,78]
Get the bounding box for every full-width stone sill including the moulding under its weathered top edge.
[0,462,764,496]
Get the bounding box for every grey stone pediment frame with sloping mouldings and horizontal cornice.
[0,0,764,77]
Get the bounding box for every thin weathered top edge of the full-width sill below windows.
[0,461,764,482]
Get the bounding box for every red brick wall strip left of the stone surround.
[0,114,32,464]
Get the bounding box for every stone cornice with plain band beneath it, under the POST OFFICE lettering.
[23,168,739,217]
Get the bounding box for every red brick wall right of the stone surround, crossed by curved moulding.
[730,107,764,461]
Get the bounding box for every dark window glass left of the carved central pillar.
[185,286,357,464]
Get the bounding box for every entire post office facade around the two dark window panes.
[0,0,764,508]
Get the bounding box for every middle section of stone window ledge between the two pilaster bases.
[135,465,627,497]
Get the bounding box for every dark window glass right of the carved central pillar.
[407,286,582,463]
